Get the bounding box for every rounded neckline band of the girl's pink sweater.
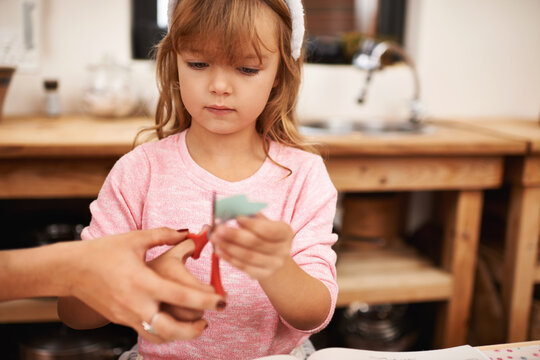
[177,129,279,194]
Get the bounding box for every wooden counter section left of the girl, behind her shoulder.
[0,116,152,198]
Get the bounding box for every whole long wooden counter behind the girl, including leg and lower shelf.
[0,117,526,347]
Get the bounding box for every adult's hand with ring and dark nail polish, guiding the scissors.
[66,228,223,343]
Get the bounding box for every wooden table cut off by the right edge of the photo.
[446,119,540,342]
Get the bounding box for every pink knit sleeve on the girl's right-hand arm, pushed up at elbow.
[282,157,338,333]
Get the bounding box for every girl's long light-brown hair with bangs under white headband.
[139,0,316,156]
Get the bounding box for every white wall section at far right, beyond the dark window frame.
[407,0,540,118]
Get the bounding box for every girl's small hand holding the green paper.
[210,213,294,280]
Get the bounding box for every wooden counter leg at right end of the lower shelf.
[435,190,483,347]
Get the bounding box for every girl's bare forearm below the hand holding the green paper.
[259,257,332,330]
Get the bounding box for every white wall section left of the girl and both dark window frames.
[0,0,131,114]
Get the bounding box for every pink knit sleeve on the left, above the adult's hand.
[81,147,150,239]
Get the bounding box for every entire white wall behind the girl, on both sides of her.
[0,0,540,119]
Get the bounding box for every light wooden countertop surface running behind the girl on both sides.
[0,115,540,158]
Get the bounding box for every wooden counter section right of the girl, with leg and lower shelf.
[319,120,525,347]
